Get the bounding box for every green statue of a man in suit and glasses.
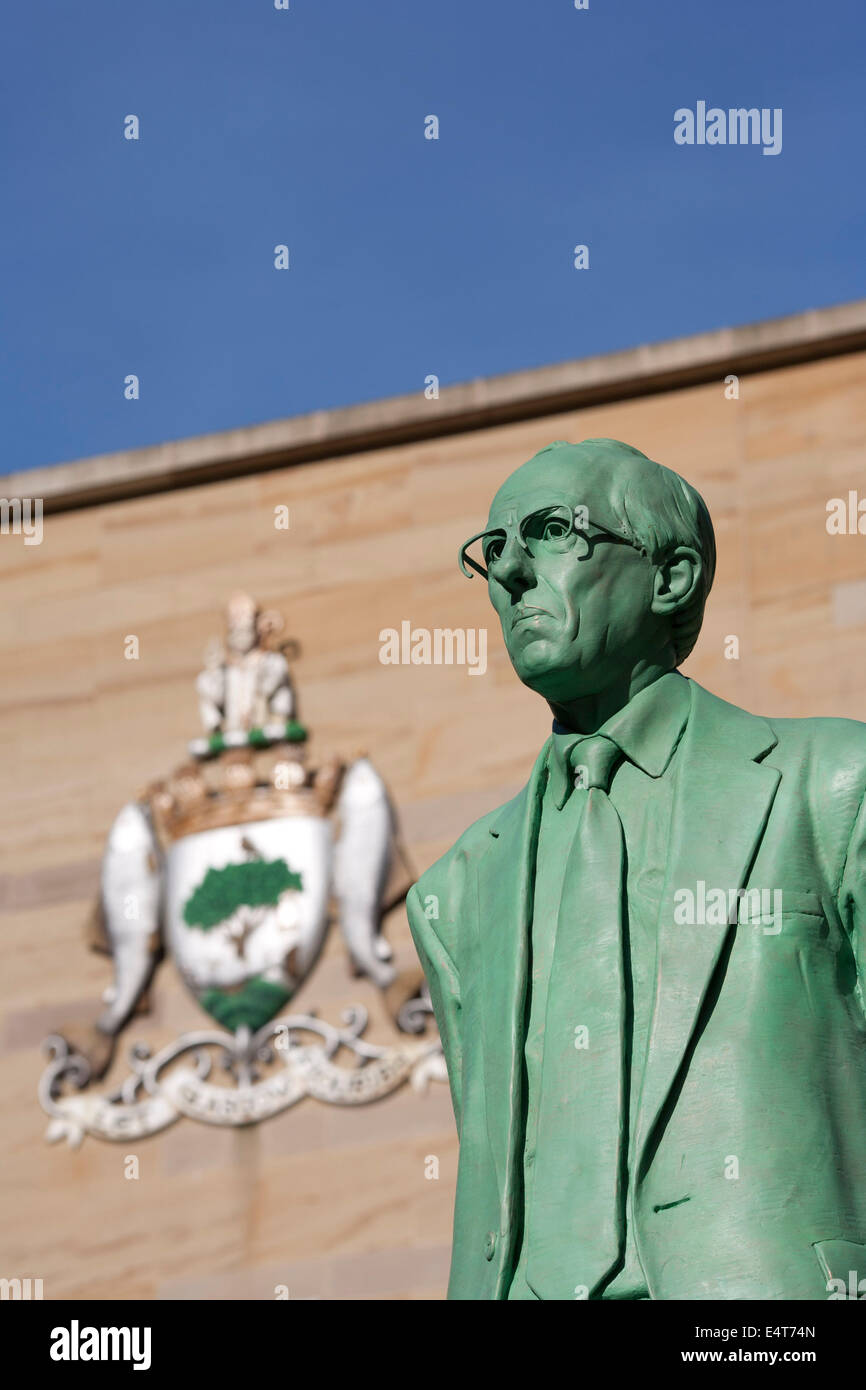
[409,439,866,1300]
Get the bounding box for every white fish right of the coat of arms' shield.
[334,758,396,990]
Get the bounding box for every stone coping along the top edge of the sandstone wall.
[6,299,866,512]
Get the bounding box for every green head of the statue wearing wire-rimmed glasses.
[460,439,716,706]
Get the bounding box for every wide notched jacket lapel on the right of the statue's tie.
[635,681,780,1179]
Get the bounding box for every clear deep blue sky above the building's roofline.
[0,0,866,473]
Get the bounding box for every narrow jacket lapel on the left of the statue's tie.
[478,739,550,1278]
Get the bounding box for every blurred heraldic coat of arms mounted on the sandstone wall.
[39,594,446,1144]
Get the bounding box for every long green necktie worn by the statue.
[527,734,626,1300]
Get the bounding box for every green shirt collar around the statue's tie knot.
[548,671,689,800]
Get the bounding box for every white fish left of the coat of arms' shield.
[97,802,163,1036]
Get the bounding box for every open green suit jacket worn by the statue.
[407,681,866,1300]
